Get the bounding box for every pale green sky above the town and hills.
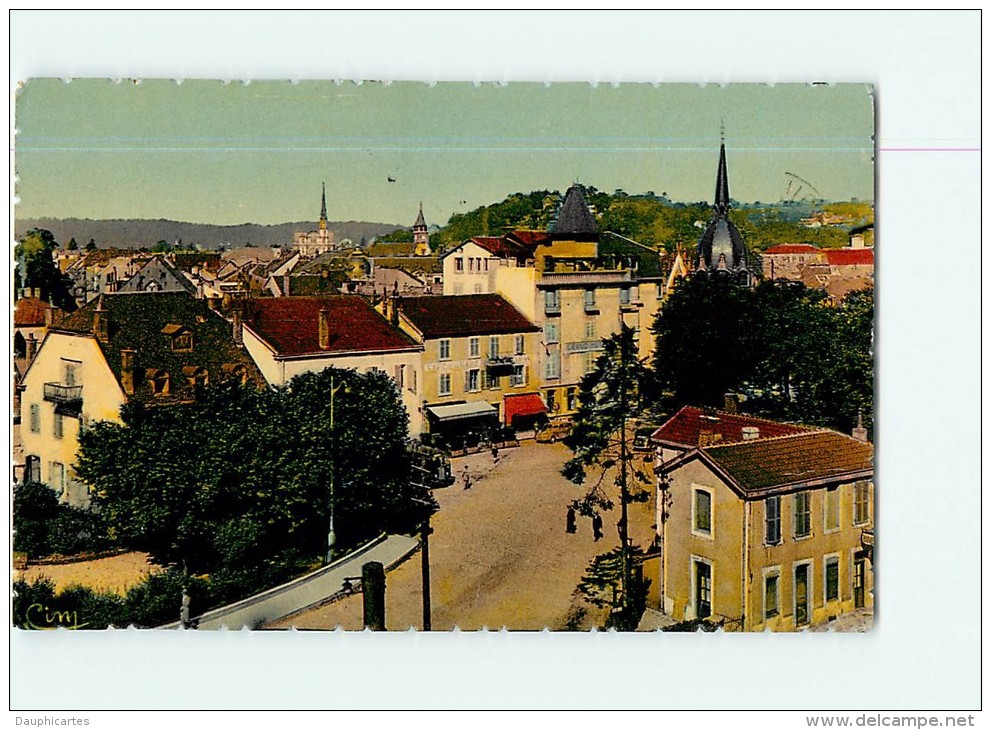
[15,79,874,225]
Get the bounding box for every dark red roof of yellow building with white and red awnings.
[398,294,539,340]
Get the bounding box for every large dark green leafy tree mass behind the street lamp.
[77,369,432,594]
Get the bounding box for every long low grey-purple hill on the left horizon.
[14,218,406,249]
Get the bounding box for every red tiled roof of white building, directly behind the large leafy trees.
[244,294,418,356]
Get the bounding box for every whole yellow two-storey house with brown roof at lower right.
[658,430,874,631]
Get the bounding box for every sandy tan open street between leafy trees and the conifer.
[265,441,653,631]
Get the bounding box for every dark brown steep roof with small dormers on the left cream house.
[56,292,265,403]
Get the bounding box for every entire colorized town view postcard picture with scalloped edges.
[12,79,876,632]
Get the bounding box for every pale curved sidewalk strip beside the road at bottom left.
[184,535,420,630]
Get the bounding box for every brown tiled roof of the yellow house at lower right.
[702,431,874,491]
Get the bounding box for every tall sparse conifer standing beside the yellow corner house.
[561,325,650,628]
